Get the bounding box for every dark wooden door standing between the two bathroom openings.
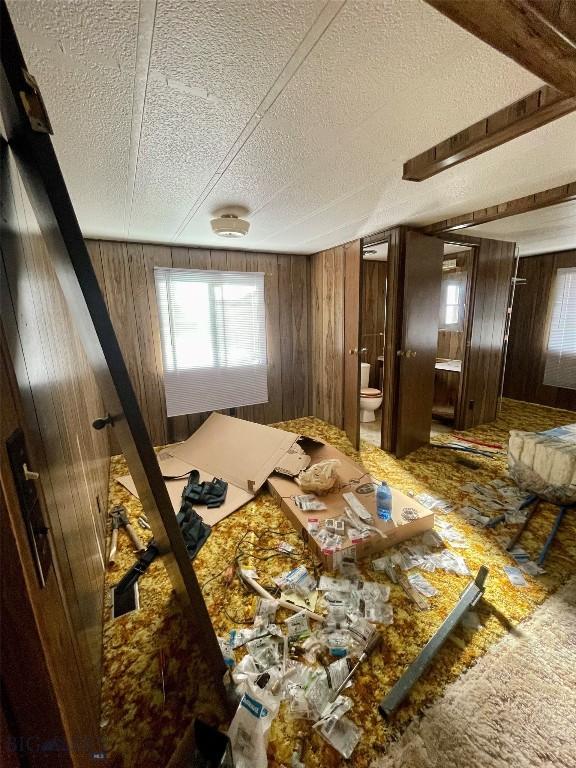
[396,231,444,457]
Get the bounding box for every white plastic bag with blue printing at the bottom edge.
[228,683,279,768]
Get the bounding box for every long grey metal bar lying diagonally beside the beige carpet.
[378,565,488,718]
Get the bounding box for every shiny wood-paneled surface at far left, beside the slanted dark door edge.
[0,147,110,735]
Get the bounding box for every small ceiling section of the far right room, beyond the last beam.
[465,200,576,256]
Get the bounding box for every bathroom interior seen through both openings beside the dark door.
[360,242,473,447]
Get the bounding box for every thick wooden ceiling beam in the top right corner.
[426,0,576,96]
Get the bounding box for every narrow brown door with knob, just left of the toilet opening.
[344,240,362,449]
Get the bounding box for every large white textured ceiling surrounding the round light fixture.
[8,0,576,253]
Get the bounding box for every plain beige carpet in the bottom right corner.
[373,578,576,768]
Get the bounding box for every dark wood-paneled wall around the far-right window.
[504,250,576,411]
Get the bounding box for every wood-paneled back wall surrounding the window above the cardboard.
[87,240,309,445]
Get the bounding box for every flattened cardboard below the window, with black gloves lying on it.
[116,413,313,525]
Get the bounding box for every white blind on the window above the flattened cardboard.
[154,268,268,416]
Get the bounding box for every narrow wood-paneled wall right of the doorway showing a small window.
[459,238,515,429]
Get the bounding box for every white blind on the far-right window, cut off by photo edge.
[544,267,576,389]
